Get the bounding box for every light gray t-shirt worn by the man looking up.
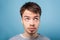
[9,34,49,40]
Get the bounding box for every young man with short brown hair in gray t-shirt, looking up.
[10,2,49,40]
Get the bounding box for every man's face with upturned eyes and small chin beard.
[22,10,40,34]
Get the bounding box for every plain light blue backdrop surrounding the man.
[0,0,60,40]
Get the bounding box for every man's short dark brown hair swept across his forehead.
[20,2,41,17]
